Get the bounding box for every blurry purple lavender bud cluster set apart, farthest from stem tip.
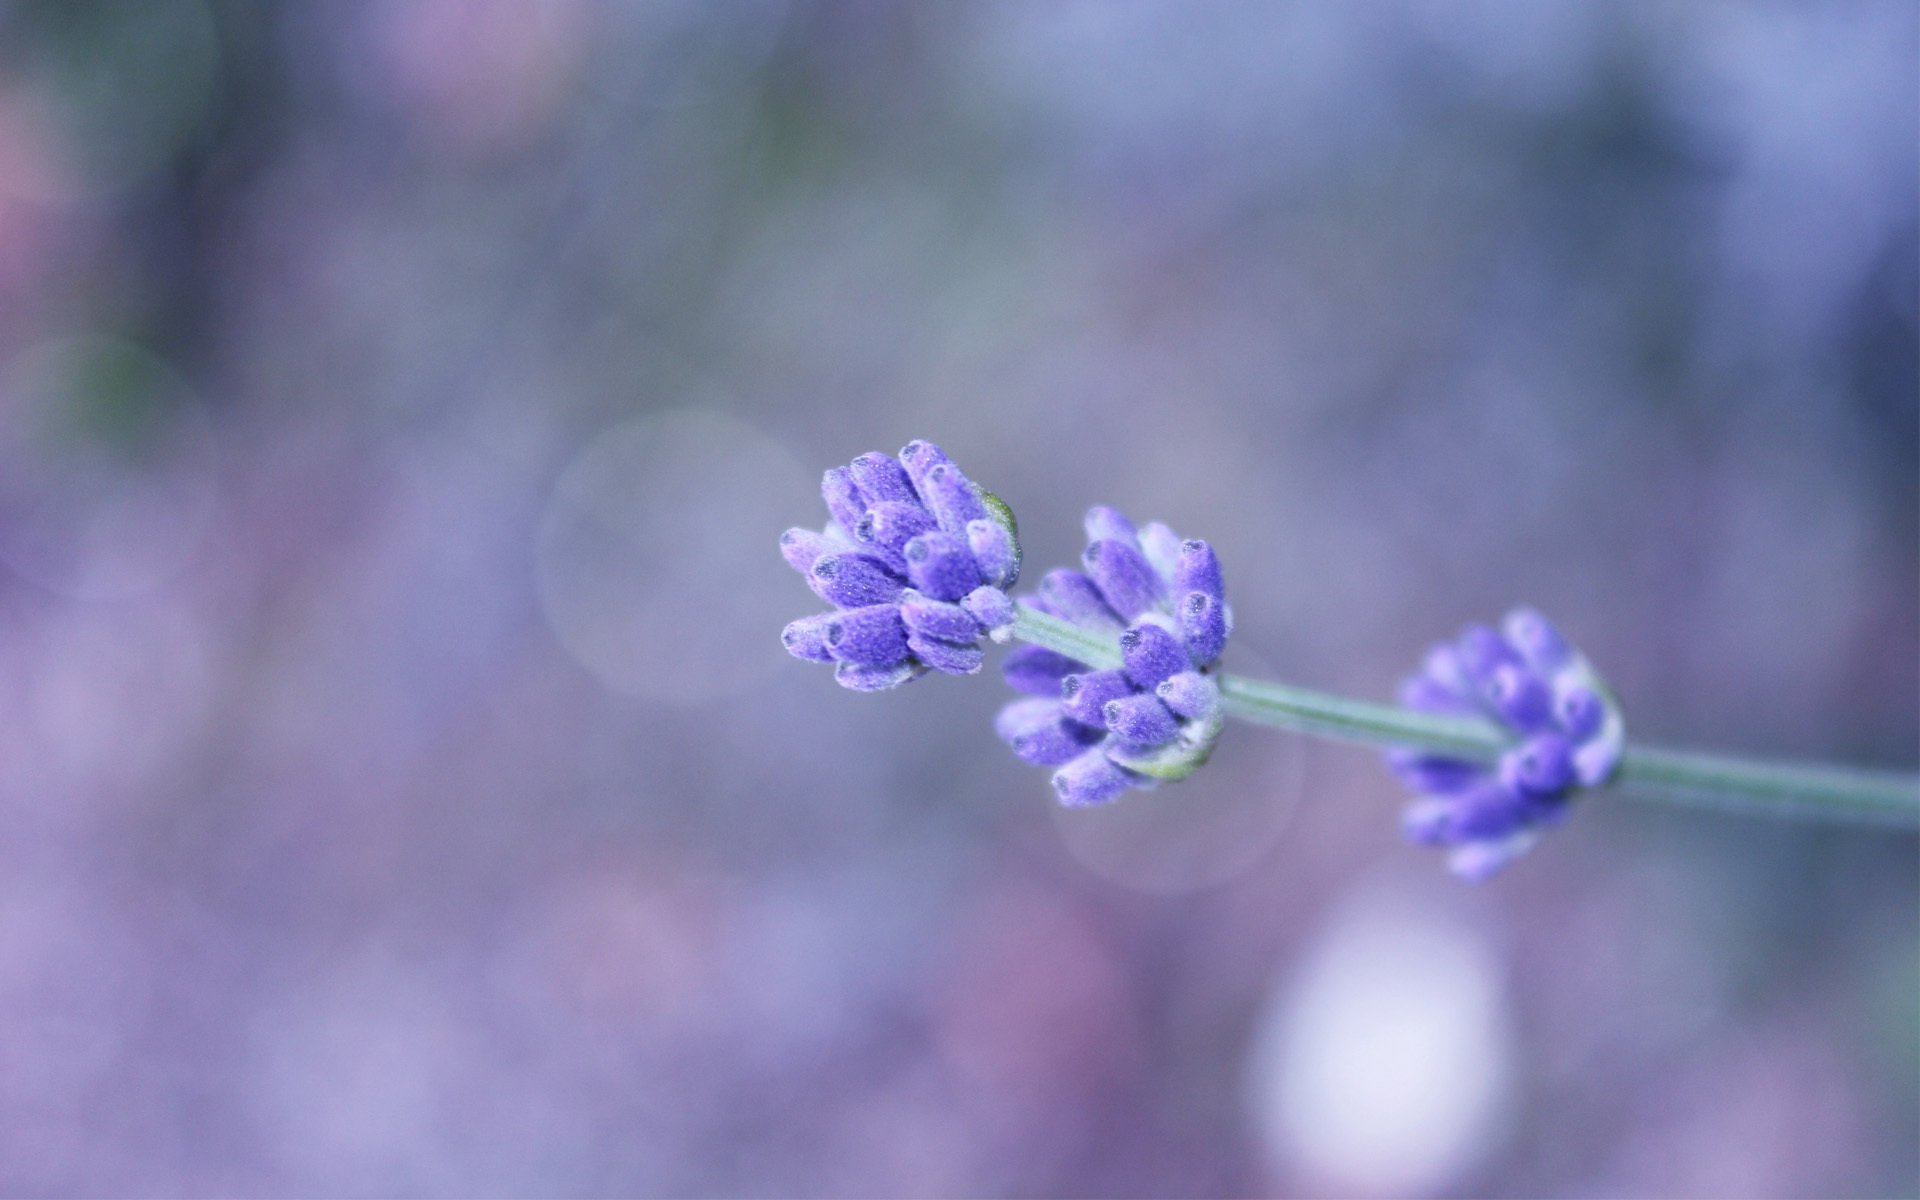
[1388,609,1626,879]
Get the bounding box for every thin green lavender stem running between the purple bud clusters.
[1014,605,1920,828]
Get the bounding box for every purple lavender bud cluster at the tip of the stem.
[780,442,1020,691]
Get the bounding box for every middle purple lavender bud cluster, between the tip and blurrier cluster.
[995,507,1233,806]
